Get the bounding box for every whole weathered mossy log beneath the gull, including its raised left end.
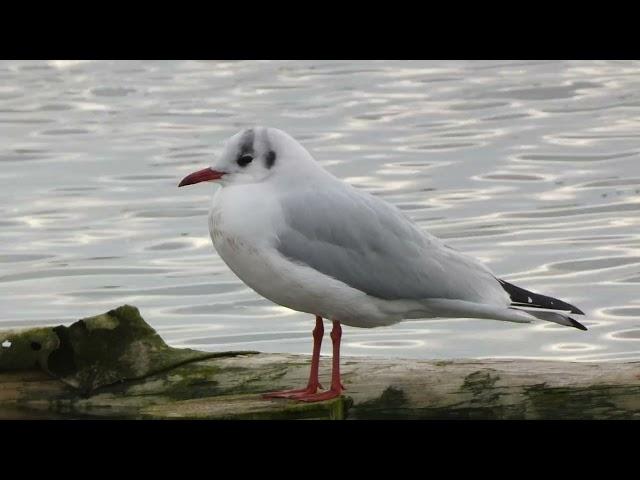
[0,306,640,419]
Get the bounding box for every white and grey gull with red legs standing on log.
[178,127,586,402]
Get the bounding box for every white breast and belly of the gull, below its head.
[209,185,400,327]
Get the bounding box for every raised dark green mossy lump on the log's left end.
[0,305,258,393]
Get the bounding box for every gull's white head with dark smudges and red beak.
[178,127,320,187]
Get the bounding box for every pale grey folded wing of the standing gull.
[277,184,508,304]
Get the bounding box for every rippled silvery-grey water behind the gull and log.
[0,61,640,361]
